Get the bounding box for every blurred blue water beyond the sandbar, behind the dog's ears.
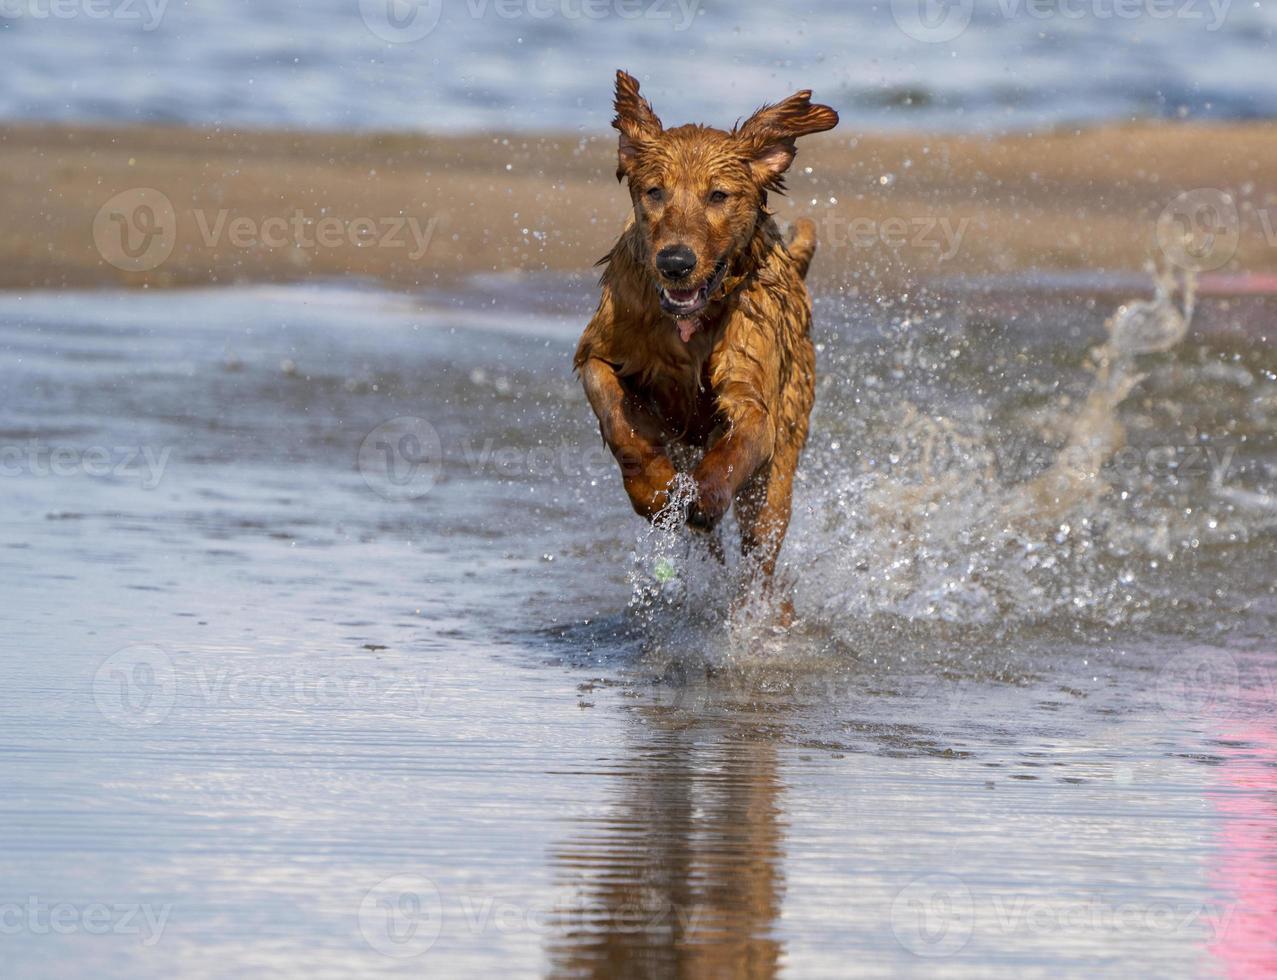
[0,0,1277,134]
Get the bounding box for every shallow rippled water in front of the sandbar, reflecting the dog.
[0,280,1277,976]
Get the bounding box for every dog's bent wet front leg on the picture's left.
[581,358,677,520]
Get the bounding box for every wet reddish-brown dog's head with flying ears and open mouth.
[612,72,838,329]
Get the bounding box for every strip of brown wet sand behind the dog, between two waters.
[0,124,1277,290]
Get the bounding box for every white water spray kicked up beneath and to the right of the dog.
[618,275,1269,651]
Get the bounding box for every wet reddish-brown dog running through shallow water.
[573,72,838,597]
